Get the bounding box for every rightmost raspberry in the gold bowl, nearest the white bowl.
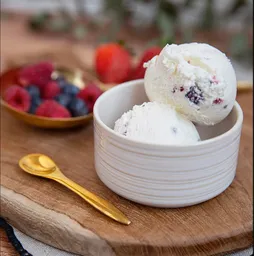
[77,84,102,112]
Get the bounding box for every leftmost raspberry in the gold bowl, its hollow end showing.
[4,85,31,112]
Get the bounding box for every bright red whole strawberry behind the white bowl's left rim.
[95,43,131,83]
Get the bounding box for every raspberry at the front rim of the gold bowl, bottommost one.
[35,100,71,118]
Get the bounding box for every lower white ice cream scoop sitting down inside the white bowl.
[114,102,200,145]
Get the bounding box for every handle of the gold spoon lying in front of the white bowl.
[53,176,131,225]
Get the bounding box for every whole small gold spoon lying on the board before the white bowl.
[19,154,131,225]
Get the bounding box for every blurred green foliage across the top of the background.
[1,0,253,62]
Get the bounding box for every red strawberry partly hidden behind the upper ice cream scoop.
[131,46,161,80]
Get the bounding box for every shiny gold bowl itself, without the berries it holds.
[0,67,93,129]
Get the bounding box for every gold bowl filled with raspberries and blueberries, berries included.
[1,62,102,128]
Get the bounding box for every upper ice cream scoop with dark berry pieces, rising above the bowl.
[144,43,237,125]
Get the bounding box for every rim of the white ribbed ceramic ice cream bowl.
[93,79,243,149]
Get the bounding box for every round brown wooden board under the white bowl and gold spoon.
[1,93,253,256]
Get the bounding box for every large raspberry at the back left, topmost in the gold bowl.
[17,62,54,88]
